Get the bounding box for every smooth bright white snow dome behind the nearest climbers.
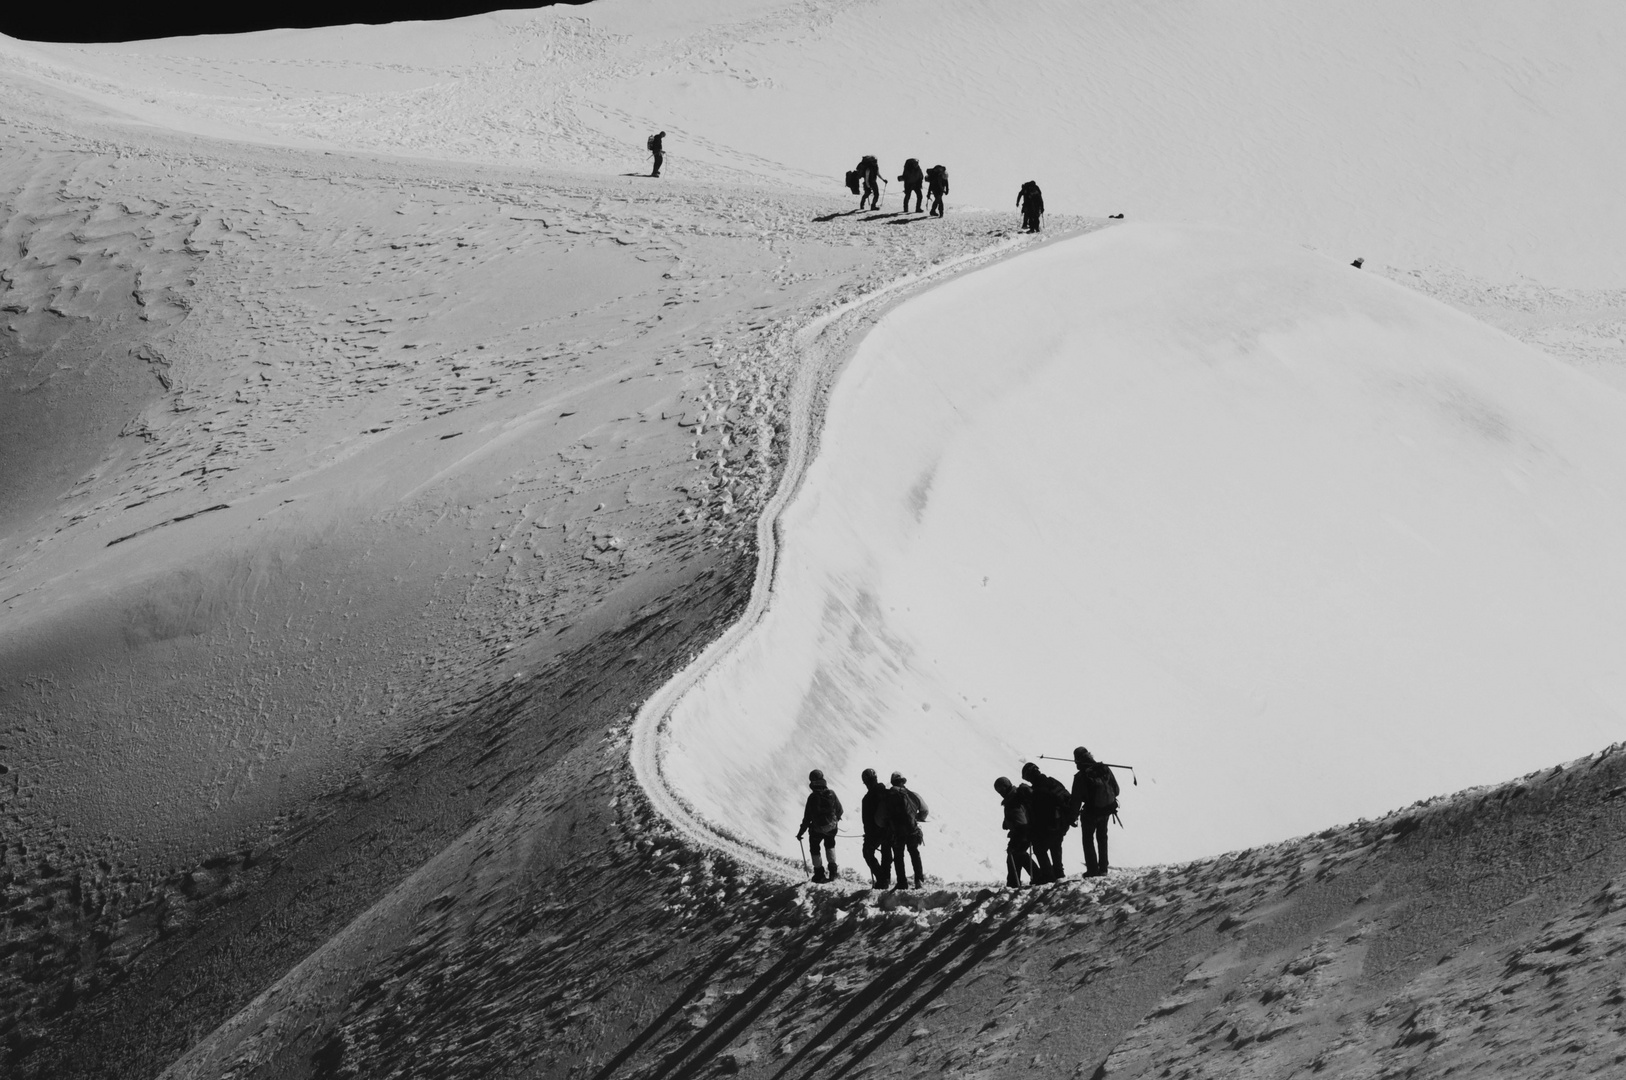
[663,226,1626,878]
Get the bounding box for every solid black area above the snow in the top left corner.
[0,0,589,42]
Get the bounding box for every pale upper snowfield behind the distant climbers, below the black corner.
[0,0,1626,286]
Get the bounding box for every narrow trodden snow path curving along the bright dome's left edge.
[629,233,1047,882]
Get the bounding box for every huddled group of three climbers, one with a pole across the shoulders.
[993,747,1119,888]
